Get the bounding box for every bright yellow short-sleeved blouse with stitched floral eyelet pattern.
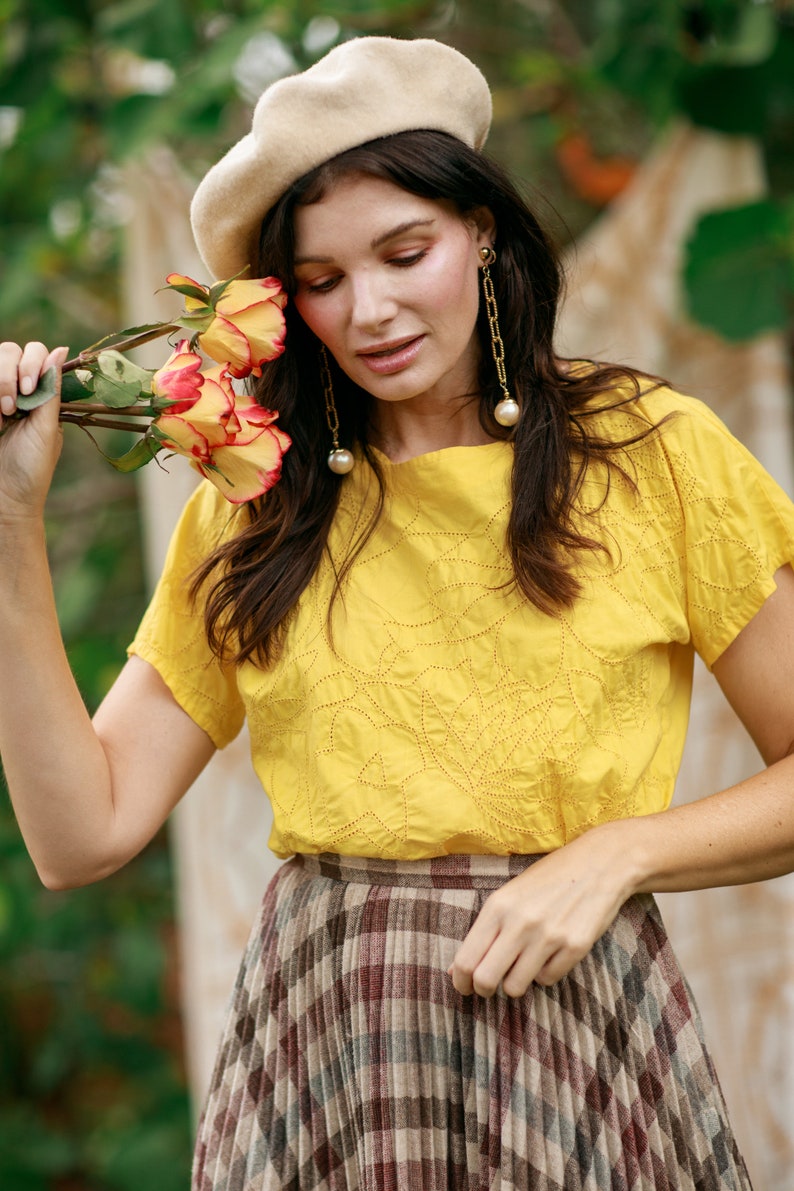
[130,389,794,859]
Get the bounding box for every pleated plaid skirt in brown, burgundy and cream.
[193,855,750,1191]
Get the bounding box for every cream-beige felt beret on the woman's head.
[190,37,490,278]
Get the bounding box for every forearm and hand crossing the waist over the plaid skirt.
[449,756,794,997]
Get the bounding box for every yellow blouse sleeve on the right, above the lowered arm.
[652,394,794,668]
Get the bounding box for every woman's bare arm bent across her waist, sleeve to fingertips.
[450,567,794,996]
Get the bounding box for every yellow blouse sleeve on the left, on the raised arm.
[127,482,245,748]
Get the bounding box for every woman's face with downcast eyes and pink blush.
[294,174,494,414]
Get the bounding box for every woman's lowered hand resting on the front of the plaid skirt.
[449,821,633,997]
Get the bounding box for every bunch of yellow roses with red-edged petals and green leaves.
[11,273,290,504]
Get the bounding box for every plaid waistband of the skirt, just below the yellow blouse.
[288,852,542,890]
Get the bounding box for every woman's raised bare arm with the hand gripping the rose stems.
[0,344,213,888]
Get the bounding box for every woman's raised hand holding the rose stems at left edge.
[0,343,68,520]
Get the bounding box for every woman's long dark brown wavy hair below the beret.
[194,131,650,666]
